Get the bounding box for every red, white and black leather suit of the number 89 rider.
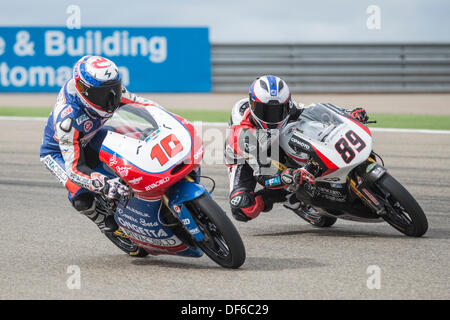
[224,98,367,221]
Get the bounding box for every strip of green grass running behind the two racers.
[0,107,450,130]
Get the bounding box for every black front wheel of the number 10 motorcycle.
[187,194,245,269]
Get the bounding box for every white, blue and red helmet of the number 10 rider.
[73,56,122,118]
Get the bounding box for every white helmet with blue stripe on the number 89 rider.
[249,75,292,129]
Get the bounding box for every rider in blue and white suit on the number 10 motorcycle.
[40,56,157,232]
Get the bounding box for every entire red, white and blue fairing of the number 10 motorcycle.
[96,105,206,257]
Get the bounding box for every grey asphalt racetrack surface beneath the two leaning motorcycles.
[0,120,450,300]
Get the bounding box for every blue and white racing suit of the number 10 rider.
[40,79,157,202]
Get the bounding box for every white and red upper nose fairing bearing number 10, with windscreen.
[100,105,204,200]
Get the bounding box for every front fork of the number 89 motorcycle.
[347,157,387,216]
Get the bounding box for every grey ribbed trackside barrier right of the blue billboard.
[211,44,450,92]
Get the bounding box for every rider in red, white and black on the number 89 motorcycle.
[224,75,368,222]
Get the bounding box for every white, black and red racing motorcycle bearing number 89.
[280,104,428,237]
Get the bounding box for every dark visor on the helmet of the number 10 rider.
[77,79,122,112]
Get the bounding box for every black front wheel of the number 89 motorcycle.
[376,174,428,237]
